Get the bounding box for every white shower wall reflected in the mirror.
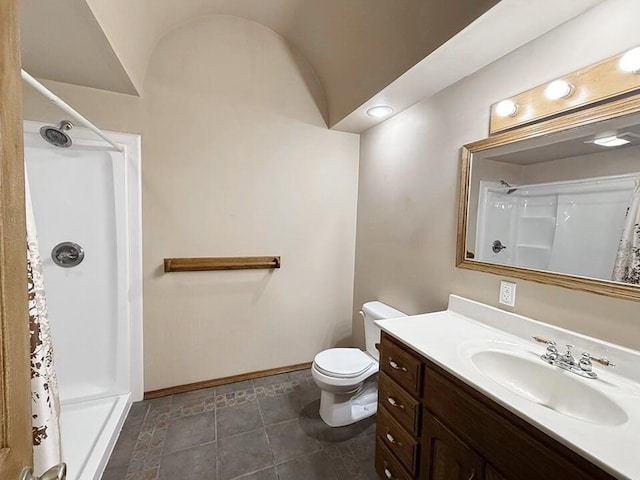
[476,178,633,279]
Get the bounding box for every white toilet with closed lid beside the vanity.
[311,301,406,427]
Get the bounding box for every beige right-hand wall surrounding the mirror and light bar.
[354,0,640,348]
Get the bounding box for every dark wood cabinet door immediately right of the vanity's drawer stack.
[421,409,484,480]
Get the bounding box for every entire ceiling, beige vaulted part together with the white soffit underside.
[21,0,603,133]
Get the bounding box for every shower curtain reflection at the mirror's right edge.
[611,180,640,285]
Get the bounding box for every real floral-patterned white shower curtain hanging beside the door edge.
[25,172,62,475]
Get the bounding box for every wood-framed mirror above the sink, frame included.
[457,95,640,299]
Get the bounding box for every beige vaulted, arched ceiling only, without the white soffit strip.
[22,0,499,125]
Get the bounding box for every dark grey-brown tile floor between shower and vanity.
[102,370,378,480]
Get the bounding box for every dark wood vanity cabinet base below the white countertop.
[376,332,615,480]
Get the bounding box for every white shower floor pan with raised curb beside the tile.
[60,394,131,480]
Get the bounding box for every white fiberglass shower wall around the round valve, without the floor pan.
[25,122,142,404]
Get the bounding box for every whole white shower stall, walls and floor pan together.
[24,122,143,480]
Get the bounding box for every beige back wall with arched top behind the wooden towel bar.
[25,16,359,390]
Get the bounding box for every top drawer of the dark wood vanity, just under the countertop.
[380,334,422,397]
